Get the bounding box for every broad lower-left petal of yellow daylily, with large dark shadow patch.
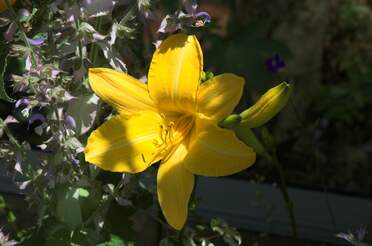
[85,112,162,173]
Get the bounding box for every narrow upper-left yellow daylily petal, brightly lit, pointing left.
[89,68,155,116]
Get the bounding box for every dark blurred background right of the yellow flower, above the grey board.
[192,0,372,197]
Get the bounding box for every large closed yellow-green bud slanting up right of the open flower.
[240,82,293,128]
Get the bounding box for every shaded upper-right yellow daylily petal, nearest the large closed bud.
[198,73,244,122]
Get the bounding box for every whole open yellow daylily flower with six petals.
[85,34,256,230]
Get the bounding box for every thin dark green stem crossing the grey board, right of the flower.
[272,151,297,245]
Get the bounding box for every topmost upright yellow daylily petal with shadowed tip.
[148,34,203,112]
